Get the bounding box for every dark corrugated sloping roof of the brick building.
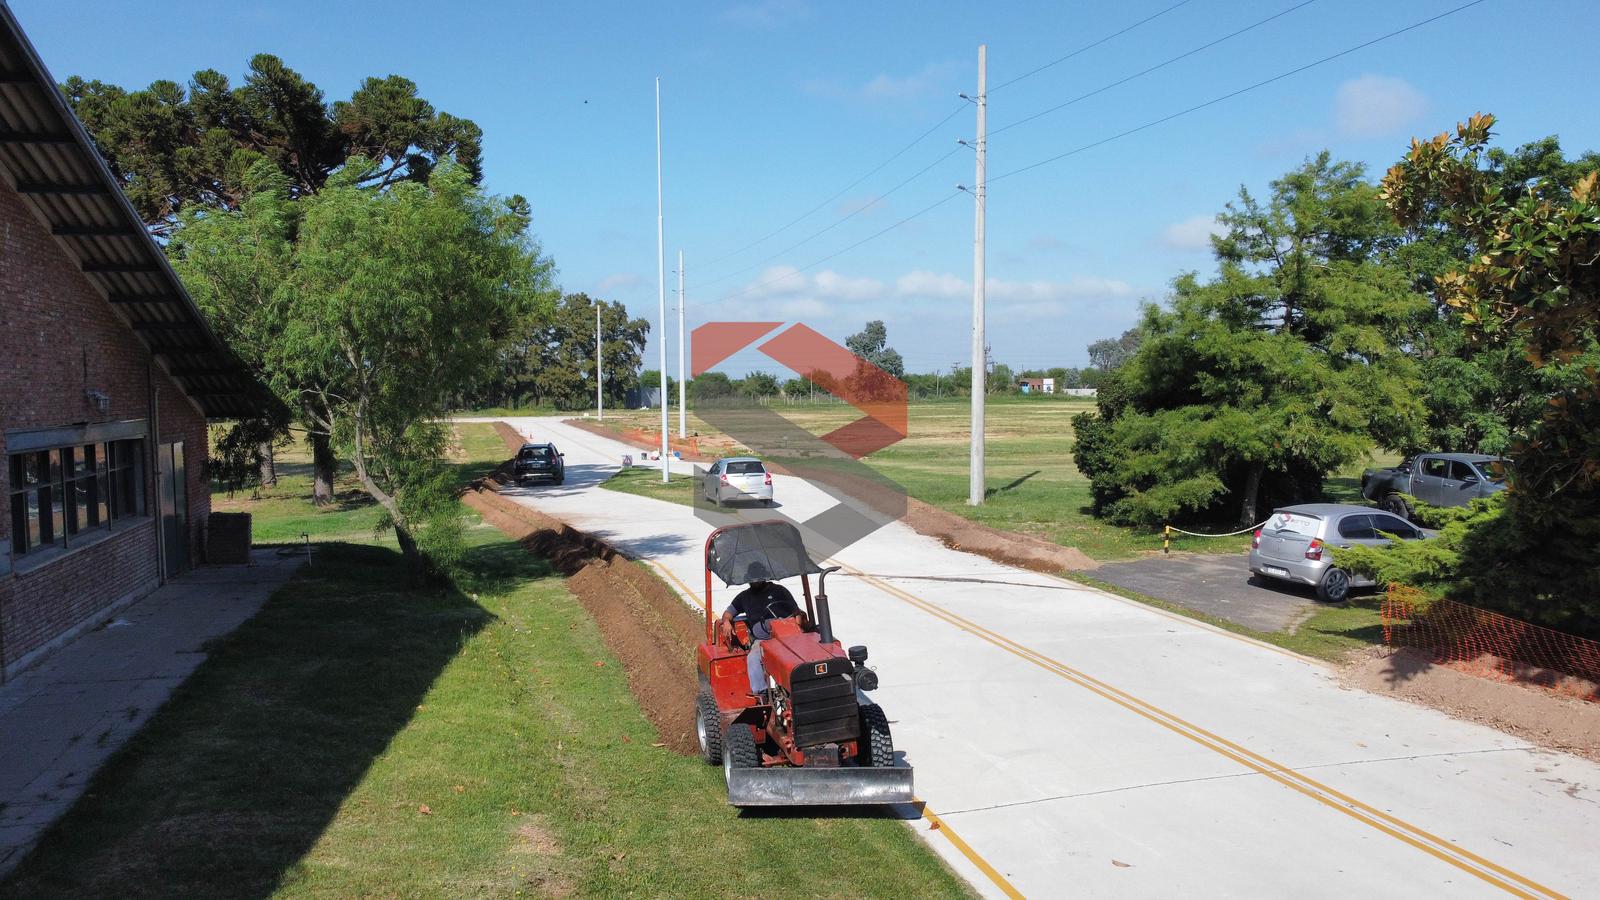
[0,2,282,418]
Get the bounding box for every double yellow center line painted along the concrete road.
[832,560,1565,898]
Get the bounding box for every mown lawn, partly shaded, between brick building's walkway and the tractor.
[0,426,966,897]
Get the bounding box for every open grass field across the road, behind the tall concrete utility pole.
[592,397,1389,560]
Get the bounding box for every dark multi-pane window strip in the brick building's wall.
[8,439,144,556]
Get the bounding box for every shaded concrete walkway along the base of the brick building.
[0,549,302,876]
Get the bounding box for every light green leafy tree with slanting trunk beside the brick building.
[179,159,554,567]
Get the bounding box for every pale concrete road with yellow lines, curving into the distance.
[467,420,1600,897]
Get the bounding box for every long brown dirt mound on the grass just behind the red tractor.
[462,477,704,754]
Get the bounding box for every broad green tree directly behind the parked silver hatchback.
[1077,154,1429,525]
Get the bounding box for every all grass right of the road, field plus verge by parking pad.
[588,397,1397,660]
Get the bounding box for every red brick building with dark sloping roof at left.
[0,10,274,677]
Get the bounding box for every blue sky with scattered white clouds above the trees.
[11,0,1600,375]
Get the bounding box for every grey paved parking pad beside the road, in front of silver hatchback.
[1090,552,1317,631]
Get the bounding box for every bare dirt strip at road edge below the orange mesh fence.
[1341,647,1600,762]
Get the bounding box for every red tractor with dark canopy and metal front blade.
[694,520,914,807]
